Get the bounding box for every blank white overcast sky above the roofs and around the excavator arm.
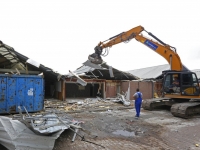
[0,0,200,74]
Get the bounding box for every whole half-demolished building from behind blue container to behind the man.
[0,42,166,112]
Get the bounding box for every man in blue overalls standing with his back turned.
[133,88,142,119]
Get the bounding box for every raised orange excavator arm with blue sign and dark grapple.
[88,26,182,71]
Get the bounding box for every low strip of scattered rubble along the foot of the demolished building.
[44,93,131,113]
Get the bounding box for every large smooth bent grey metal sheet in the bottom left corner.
[0,116,64,150]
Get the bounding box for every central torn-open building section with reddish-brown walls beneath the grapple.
[65,61,157,100]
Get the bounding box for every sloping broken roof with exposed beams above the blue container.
[0,41,61,80]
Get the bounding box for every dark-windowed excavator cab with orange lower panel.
[163,71,199,99]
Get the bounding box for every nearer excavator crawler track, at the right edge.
[171,102,200,118]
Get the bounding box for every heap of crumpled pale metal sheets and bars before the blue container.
[0,107,82,150]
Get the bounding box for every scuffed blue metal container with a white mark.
[0,74,44,114]
